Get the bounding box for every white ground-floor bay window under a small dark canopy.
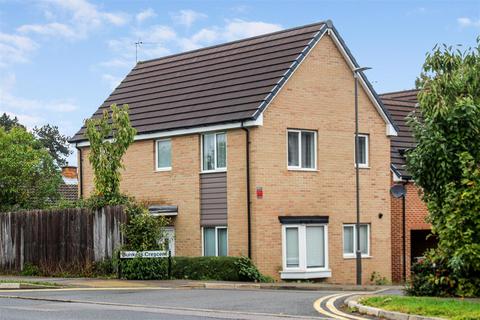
[281,224,331,279]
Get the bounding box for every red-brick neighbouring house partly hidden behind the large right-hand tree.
[380,89,436,282]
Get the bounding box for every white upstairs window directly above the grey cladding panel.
[201,132,227,172]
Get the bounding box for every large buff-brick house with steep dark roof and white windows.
[72,21,396,283]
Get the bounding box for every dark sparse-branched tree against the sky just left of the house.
[33,124,72,167]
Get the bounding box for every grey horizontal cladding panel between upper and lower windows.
[200,172,227,226]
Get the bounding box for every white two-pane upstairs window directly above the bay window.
[287,129,317,170]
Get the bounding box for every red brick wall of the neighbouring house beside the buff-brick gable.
[390,182,430,282]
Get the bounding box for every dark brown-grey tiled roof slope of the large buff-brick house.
[71,22,326,142]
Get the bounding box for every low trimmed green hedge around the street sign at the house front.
[120,257,272,282]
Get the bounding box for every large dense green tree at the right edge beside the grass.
[407,38,480,294]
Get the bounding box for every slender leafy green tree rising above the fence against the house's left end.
[86,104,136,201]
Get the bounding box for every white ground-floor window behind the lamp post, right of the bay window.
[343,223,370,258]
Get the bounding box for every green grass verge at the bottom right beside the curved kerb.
[360,296,480,320]
